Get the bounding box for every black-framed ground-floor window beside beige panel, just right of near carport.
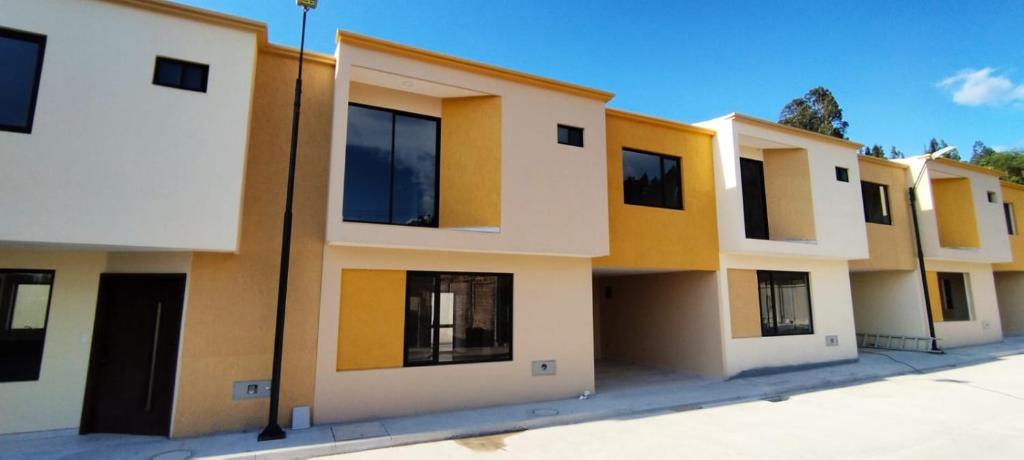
[758,270,814,337]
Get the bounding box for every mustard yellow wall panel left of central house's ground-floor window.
[337,269,406,371]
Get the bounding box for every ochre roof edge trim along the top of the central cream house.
[336,29,614,102]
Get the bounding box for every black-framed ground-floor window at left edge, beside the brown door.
[0,269,53,382]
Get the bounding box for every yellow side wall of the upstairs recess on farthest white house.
[932,177,981,248]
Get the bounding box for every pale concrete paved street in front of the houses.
[325,354,1024,460]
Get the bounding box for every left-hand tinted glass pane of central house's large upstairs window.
[342,106,393,223]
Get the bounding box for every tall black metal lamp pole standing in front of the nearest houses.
[257,7,309,441]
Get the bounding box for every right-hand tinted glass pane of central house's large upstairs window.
[391,115,437,226]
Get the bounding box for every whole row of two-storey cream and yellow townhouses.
[0,0,1024,436]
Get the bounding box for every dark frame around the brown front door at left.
[78,273,188,436]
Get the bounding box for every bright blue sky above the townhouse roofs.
[182,0,1024,157]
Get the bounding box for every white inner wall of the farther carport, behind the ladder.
[850,270,929,337]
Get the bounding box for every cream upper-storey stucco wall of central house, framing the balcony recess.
[327,43,608,257]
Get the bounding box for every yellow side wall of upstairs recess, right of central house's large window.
[439,96,502,227]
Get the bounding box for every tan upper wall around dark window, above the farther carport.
[850,157,916,271]
